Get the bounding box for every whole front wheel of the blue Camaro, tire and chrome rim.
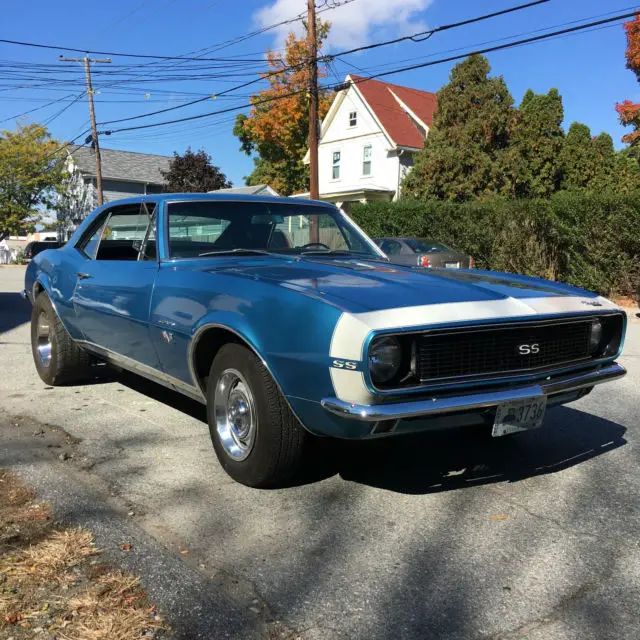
[207,344,312,488]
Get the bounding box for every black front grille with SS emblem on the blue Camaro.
[418,321,591,382]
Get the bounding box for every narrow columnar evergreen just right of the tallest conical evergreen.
[510,89,564,198]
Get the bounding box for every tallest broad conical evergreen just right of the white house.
[403,54,515,200]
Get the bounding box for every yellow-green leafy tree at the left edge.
[0,124,65,240]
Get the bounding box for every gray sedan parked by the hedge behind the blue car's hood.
[374,238,475,269]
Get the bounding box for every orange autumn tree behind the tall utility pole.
[233,21,331,195]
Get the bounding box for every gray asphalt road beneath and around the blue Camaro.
[0,267,640,640]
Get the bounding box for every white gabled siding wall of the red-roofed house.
[318,87,399,196]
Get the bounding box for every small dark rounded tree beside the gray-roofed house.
[161,148,232,193]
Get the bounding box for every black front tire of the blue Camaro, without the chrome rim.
[207,344,313,488]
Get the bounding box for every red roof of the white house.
[348,74,436,149]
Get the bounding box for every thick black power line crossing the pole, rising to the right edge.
[103,11,636,135]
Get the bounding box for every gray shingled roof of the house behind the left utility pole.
[70,146,171,184]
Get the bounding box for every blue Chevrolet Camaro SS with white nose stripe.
[24,194,626,487]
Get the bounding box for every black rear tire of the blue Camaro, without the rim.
[31,291,91,386]
